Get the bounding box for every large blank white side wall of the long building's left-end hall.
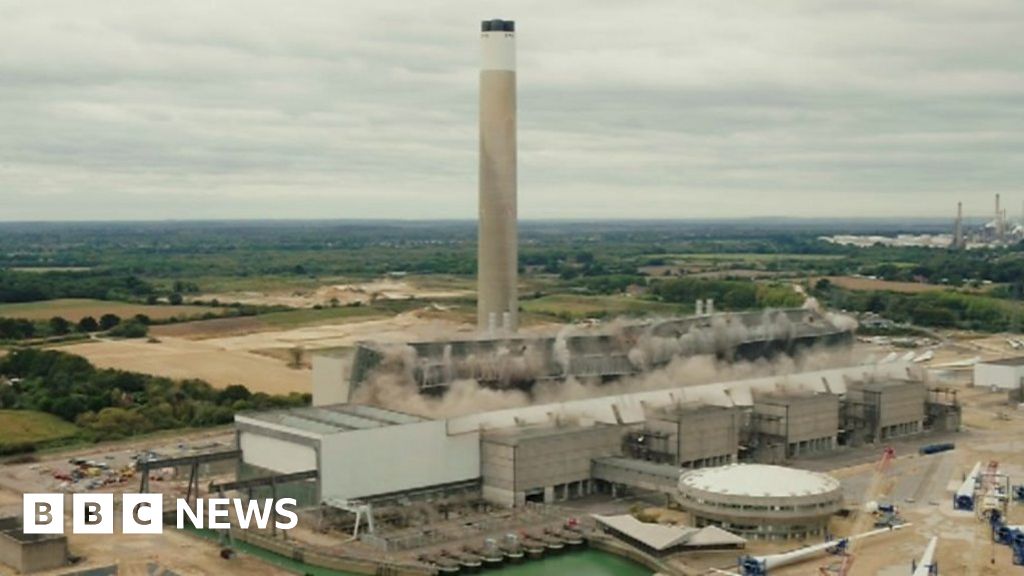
[321,420,480,499]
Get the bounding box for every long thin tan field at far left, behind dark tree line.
[0,298,221,322]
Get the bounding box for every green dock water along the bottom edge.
[187,531,651,576]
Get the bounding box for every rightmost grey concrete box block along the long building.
[844,380,928,445]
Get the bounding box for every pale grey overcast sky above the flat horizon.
[0,0,1024,220]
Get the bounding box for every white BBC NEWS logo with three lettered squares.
[22,493,299,534]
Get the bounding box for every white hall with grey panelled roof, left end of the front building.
[234,405,480,503]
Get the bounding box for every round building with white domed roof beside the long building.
[676,464,843,540]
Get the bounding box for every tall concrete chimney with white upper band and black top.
[476,19,519,332]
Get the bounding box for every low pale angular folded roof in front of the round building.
[591,515,746,552]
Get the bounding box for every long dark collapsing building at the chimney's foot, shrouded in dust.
[312,308,853,405]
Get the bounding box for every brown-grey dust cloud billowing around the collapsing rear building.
[352,312,859,418]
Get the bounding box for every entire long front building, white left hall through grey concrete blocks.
[236,362,927,506]
